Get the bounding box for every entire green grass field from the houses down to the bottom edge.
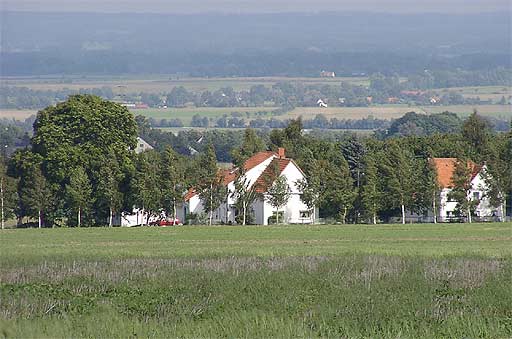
[0,223,512,338]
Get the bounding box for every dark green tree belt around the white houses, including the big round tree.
[0,95,512,226]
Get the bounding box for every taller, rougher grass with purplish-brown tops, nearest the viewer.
[0,255,512,338]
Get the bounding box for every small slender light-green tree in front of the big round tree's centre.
[66,167,92,227]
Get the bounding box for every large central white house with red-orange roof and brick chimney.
[184,148,318,225]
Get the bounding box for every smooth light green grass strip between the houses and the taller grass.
[0,223,512,267]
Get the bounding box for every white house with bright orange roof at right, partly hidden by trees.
[429,158,505,222]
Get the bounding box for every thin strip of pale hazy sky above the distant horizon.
[0,0,512,13]
